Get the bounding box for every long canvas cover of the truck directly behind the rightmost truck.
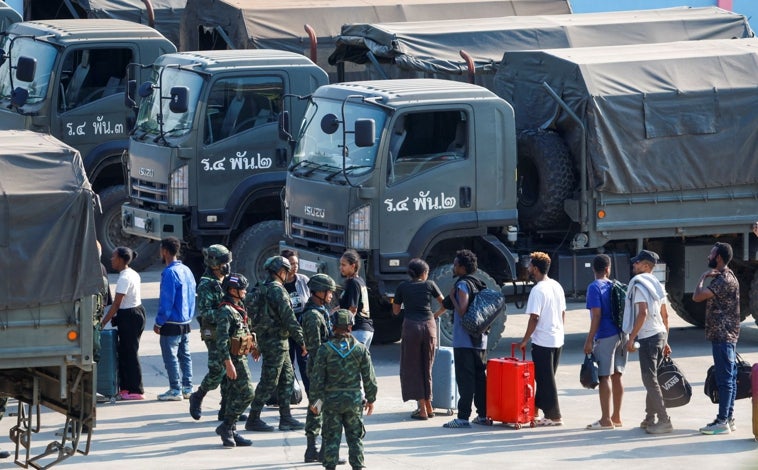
[329,7,753,74]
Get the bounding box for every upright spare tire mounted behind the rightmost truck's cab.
[518,130,576,230]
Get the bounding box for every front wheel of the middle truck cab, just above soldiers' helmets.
[232,220,284,285]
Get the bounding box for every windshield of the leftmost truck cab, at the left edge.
[0,36,58,105]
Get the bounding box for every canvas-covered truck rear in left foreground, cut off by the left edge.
[0,131,103,468]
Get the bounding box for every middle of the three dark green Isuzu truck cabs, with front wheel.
[121,49,328,278]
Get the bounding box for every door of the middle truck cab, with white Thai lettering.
[197,75,286,216]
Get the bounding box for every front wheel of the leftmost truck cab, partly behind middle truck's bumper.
[95,185,159,271]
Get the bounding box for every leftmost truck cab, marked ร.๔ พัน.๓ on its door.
[0,19,176,269]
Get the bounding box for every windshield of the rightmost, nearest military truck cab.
[293,100,386,175]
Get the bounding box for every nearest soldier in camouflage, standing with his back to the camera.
[308,309,377,469]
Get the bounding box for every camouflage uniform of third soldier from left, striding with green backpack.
[245,276,303,431]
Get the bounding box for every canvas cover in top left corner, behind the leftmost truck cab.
[25,0,187,47]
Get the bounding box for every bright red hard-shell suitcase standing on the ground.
[487,343,535,429]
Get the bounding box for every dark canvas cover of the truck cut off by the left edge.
[0,131,103,310]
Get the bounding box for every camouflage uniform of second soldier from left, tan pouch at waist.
[215,295,255,426]
